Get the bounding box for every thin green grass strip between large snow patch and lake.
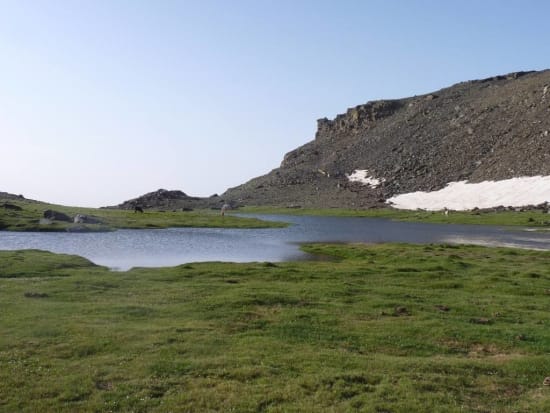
[239,207,550,228]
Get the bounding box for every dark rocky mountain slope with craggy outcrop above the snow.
[221,70,550,207]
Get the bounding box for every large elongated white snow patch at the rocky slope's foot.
[387,176,550,211]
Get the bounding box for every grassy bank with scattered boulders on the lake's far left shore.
[0,200,285,231]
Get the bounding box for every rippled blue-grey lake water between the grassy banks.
[0,214,550,270]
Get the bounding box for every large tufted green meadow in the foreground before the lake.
[0,244,550,413]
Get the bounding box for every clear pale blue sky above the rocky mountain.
[0,0,550,206]
